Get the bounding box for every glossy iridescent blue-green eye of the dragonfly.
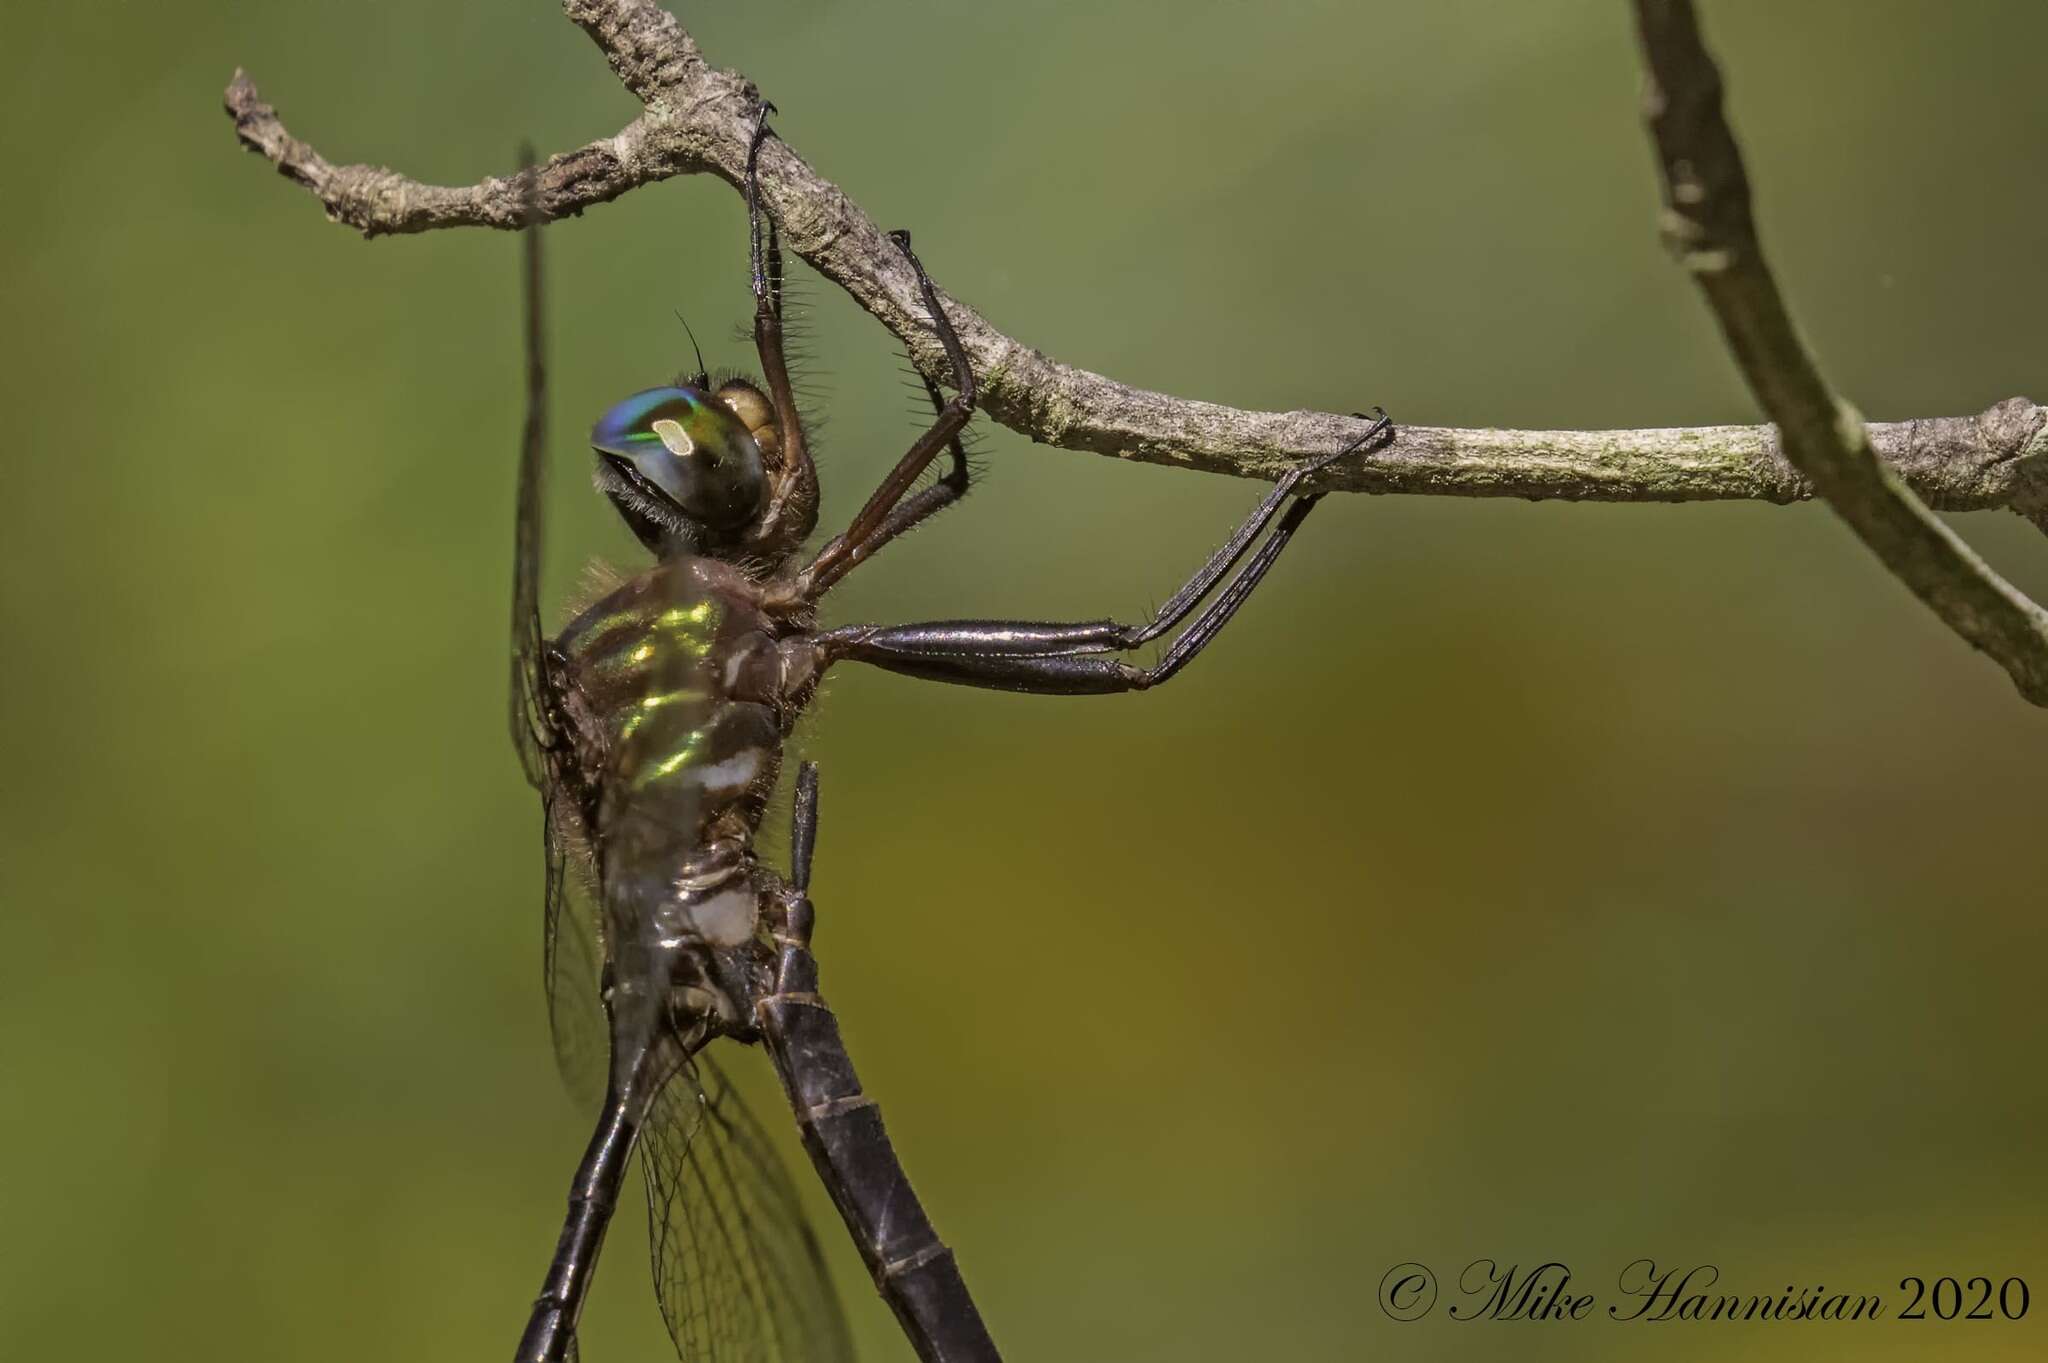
[590,387,768,530]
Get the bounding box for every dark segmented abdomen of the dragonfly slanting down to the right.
[754,761,1001,1363]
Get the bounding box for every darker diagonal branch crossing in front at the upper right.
[1636,0,2048,706]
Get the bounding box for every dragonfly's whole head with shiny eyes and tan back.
[590,381,778,553]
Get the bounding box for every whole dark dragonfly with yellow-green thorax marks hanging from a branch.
[510,102,1391,1363]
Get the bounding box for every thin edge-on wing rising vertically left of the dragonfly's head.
[512,160,555,790]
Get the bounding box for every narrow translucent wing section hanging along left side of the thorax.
[541,788,610,1109]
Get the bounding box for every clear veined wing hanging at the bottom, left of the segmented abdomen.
[641,1043,854,1363]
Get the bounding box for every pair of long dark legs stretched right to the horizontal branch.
[817,413,1393,696]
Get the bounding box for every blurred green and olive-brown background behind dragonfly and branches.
[0,0,2048,1363]
